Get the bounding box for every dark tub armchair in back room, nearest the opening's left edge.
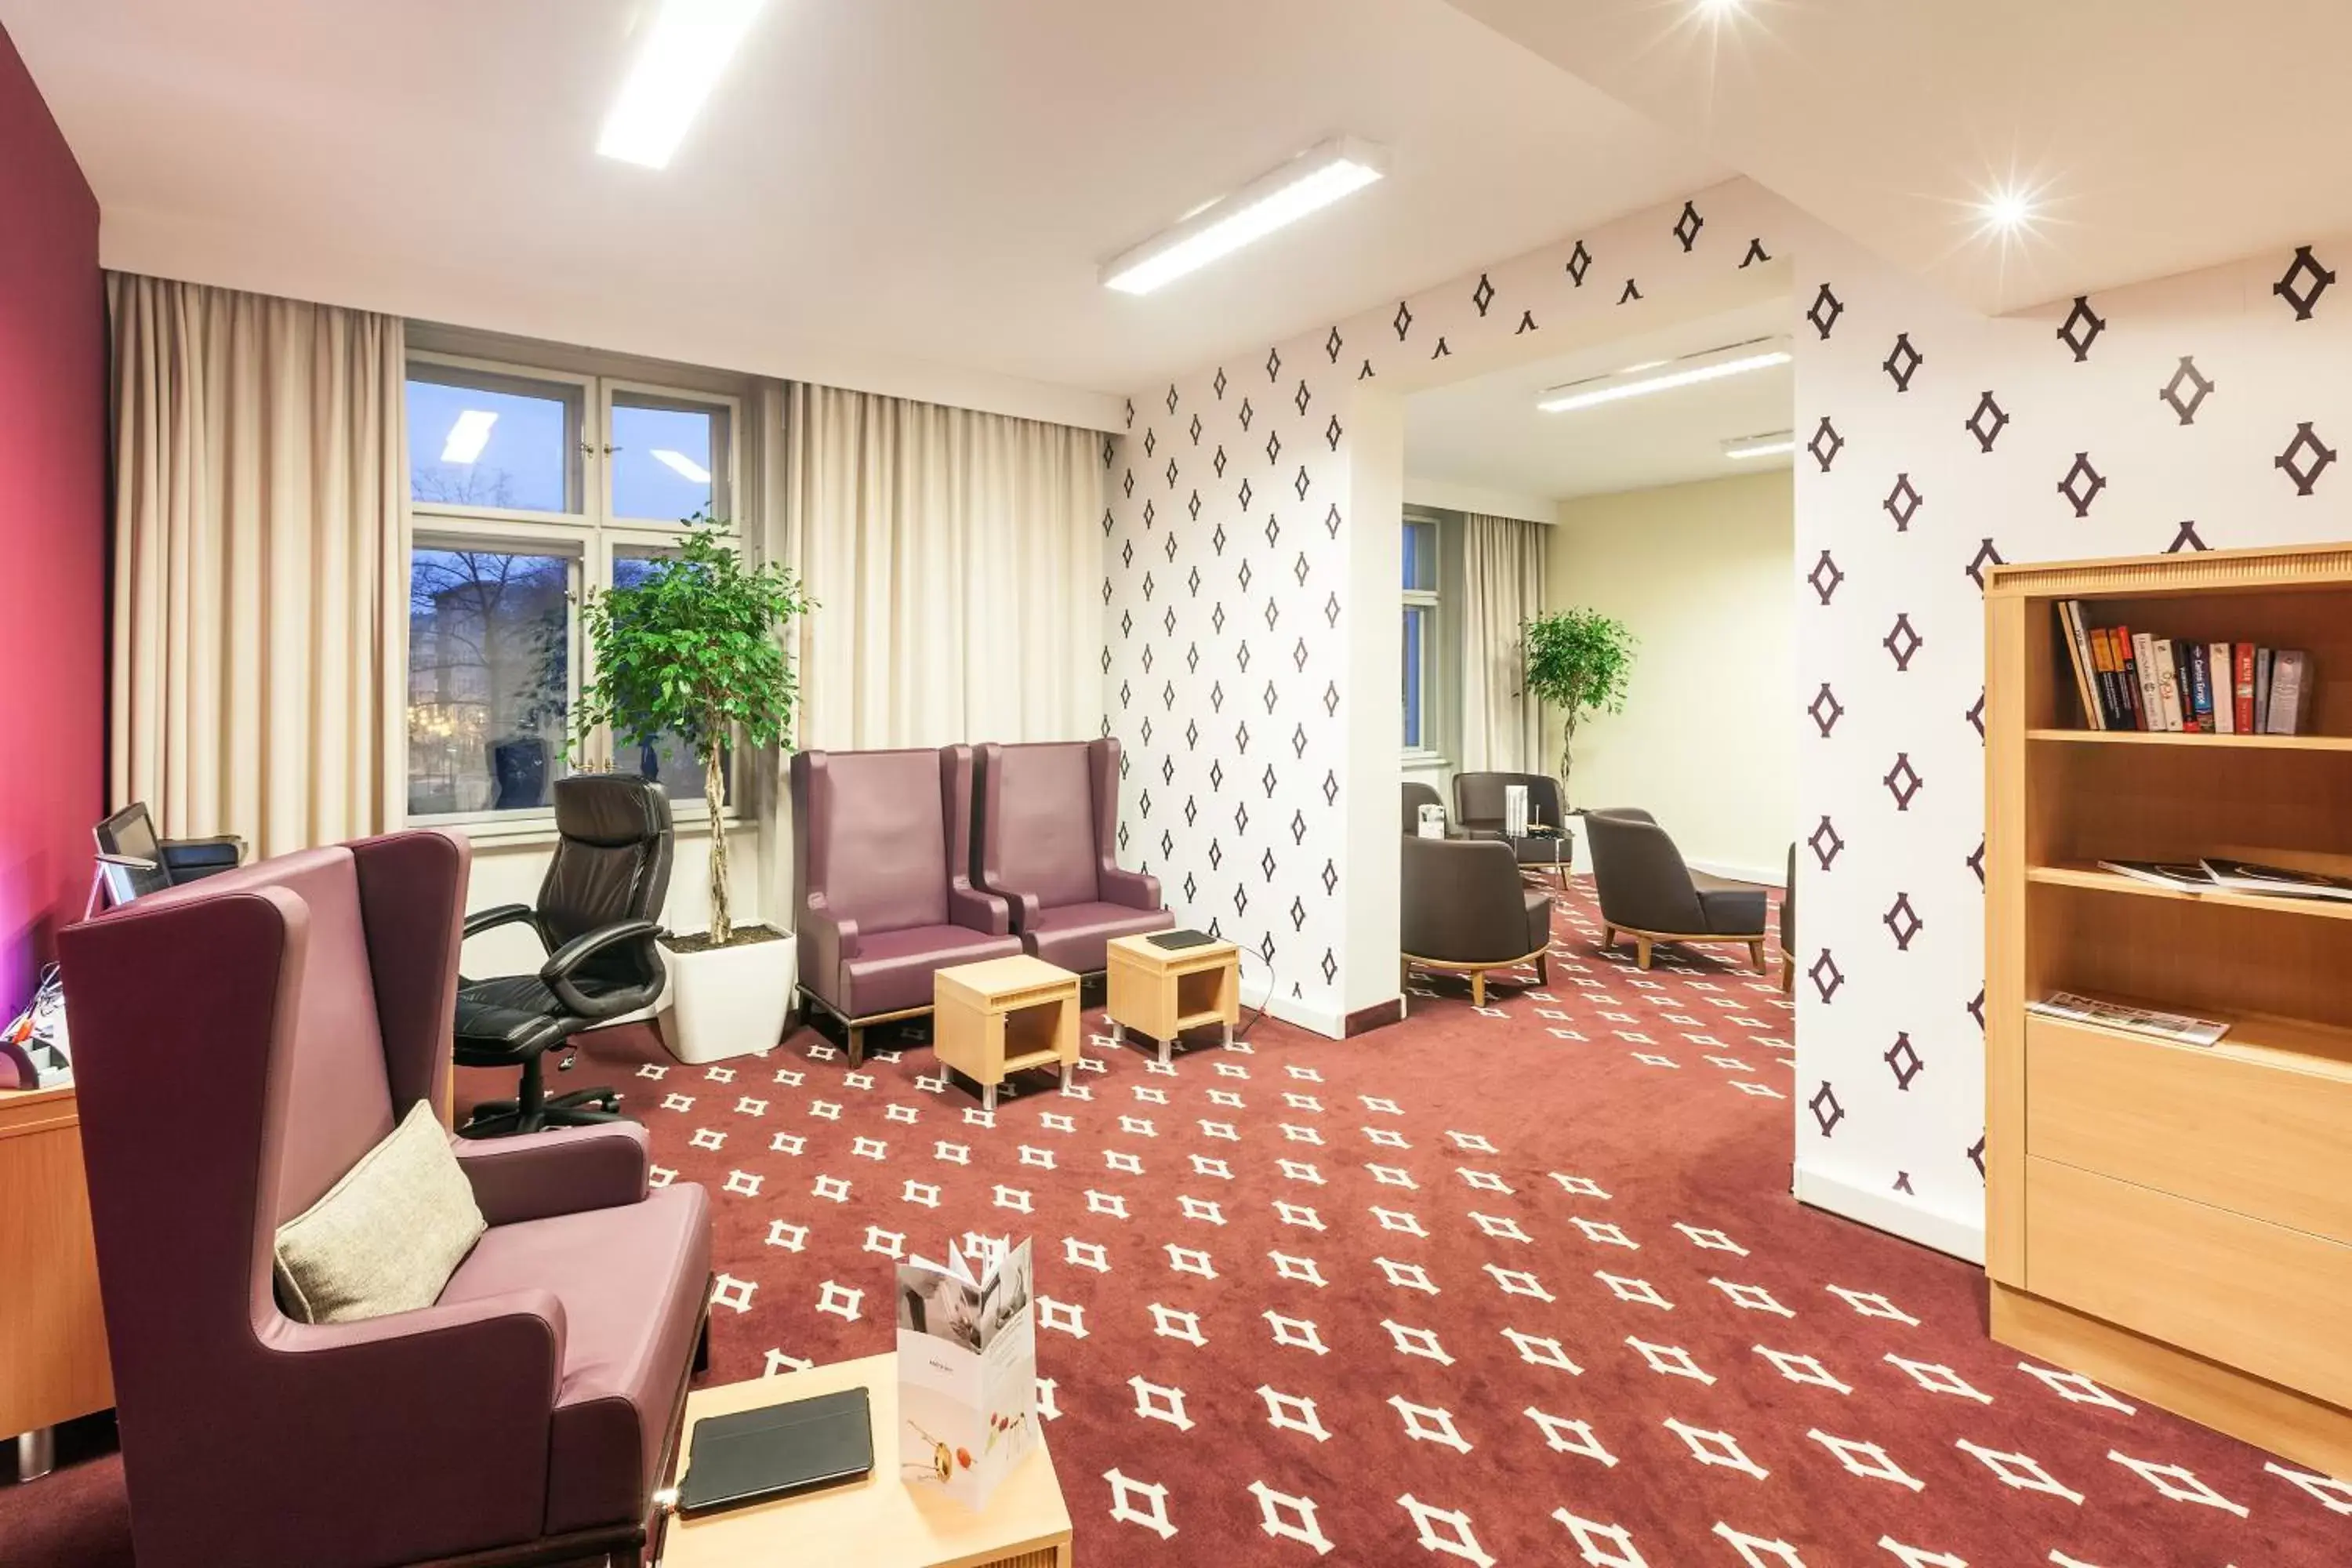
[1397,783,1552,1006]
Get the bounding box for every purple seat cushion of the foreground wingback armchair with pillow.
[440,1185,710,1535]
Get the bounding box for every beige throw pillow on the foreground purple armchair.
[275,1100,489,1323]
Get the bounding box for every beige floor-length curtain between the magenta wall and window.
[106,273,407,855]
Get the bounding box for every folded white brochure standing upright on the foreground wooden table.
[896,1236,1037,1509]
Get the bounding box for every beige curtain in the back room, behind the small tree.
[1461,513,1550,774]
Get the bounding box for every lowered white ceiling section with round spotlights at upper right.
[1451,0,2352,313]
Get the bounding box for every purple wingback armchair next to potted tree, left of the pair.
[793,746,1021,1062]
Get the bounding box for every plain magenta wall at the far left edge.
[0,31,106,1025]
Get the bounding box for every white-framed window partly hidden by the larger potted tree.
[407,353,739,825]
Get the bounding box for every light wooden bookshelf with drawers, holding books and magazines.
[1985,546,2352,1474]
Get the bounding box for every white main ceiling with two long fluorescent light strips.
[0,0,1726,421]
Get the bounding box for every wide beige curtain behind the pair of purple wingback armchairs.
[764,386,1103,750]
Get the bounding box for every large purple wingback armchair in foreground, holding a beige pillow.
[59,832,710,1568]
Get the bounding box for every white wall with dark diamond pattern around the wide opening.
[1101,181,2352,1255]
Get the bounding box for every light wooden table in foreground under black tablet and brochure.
[661,1356,1070,1568]
